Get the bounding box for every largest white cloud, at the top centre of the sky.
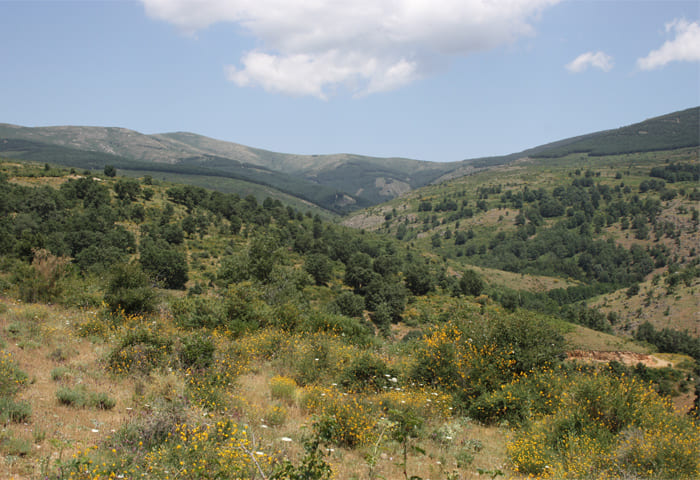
[142,0,560,98]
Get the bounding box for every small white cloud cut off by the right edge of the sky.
[637,19,700,70]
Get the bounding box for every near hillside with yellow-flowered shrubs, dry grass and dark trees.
[0,159,700,480]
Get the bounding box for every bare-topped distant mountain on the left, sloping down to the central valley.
[0,124,454,213]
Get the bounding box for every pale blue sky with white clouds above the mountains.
[0,0,700,162]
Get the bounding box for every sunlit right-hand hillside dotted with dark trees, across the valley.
[344,148,700,336]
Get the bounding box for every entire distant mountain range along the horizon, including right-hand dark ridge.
[0,107,700,214]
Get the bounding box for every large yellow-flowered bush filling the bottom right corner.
[508,374,700,479]
